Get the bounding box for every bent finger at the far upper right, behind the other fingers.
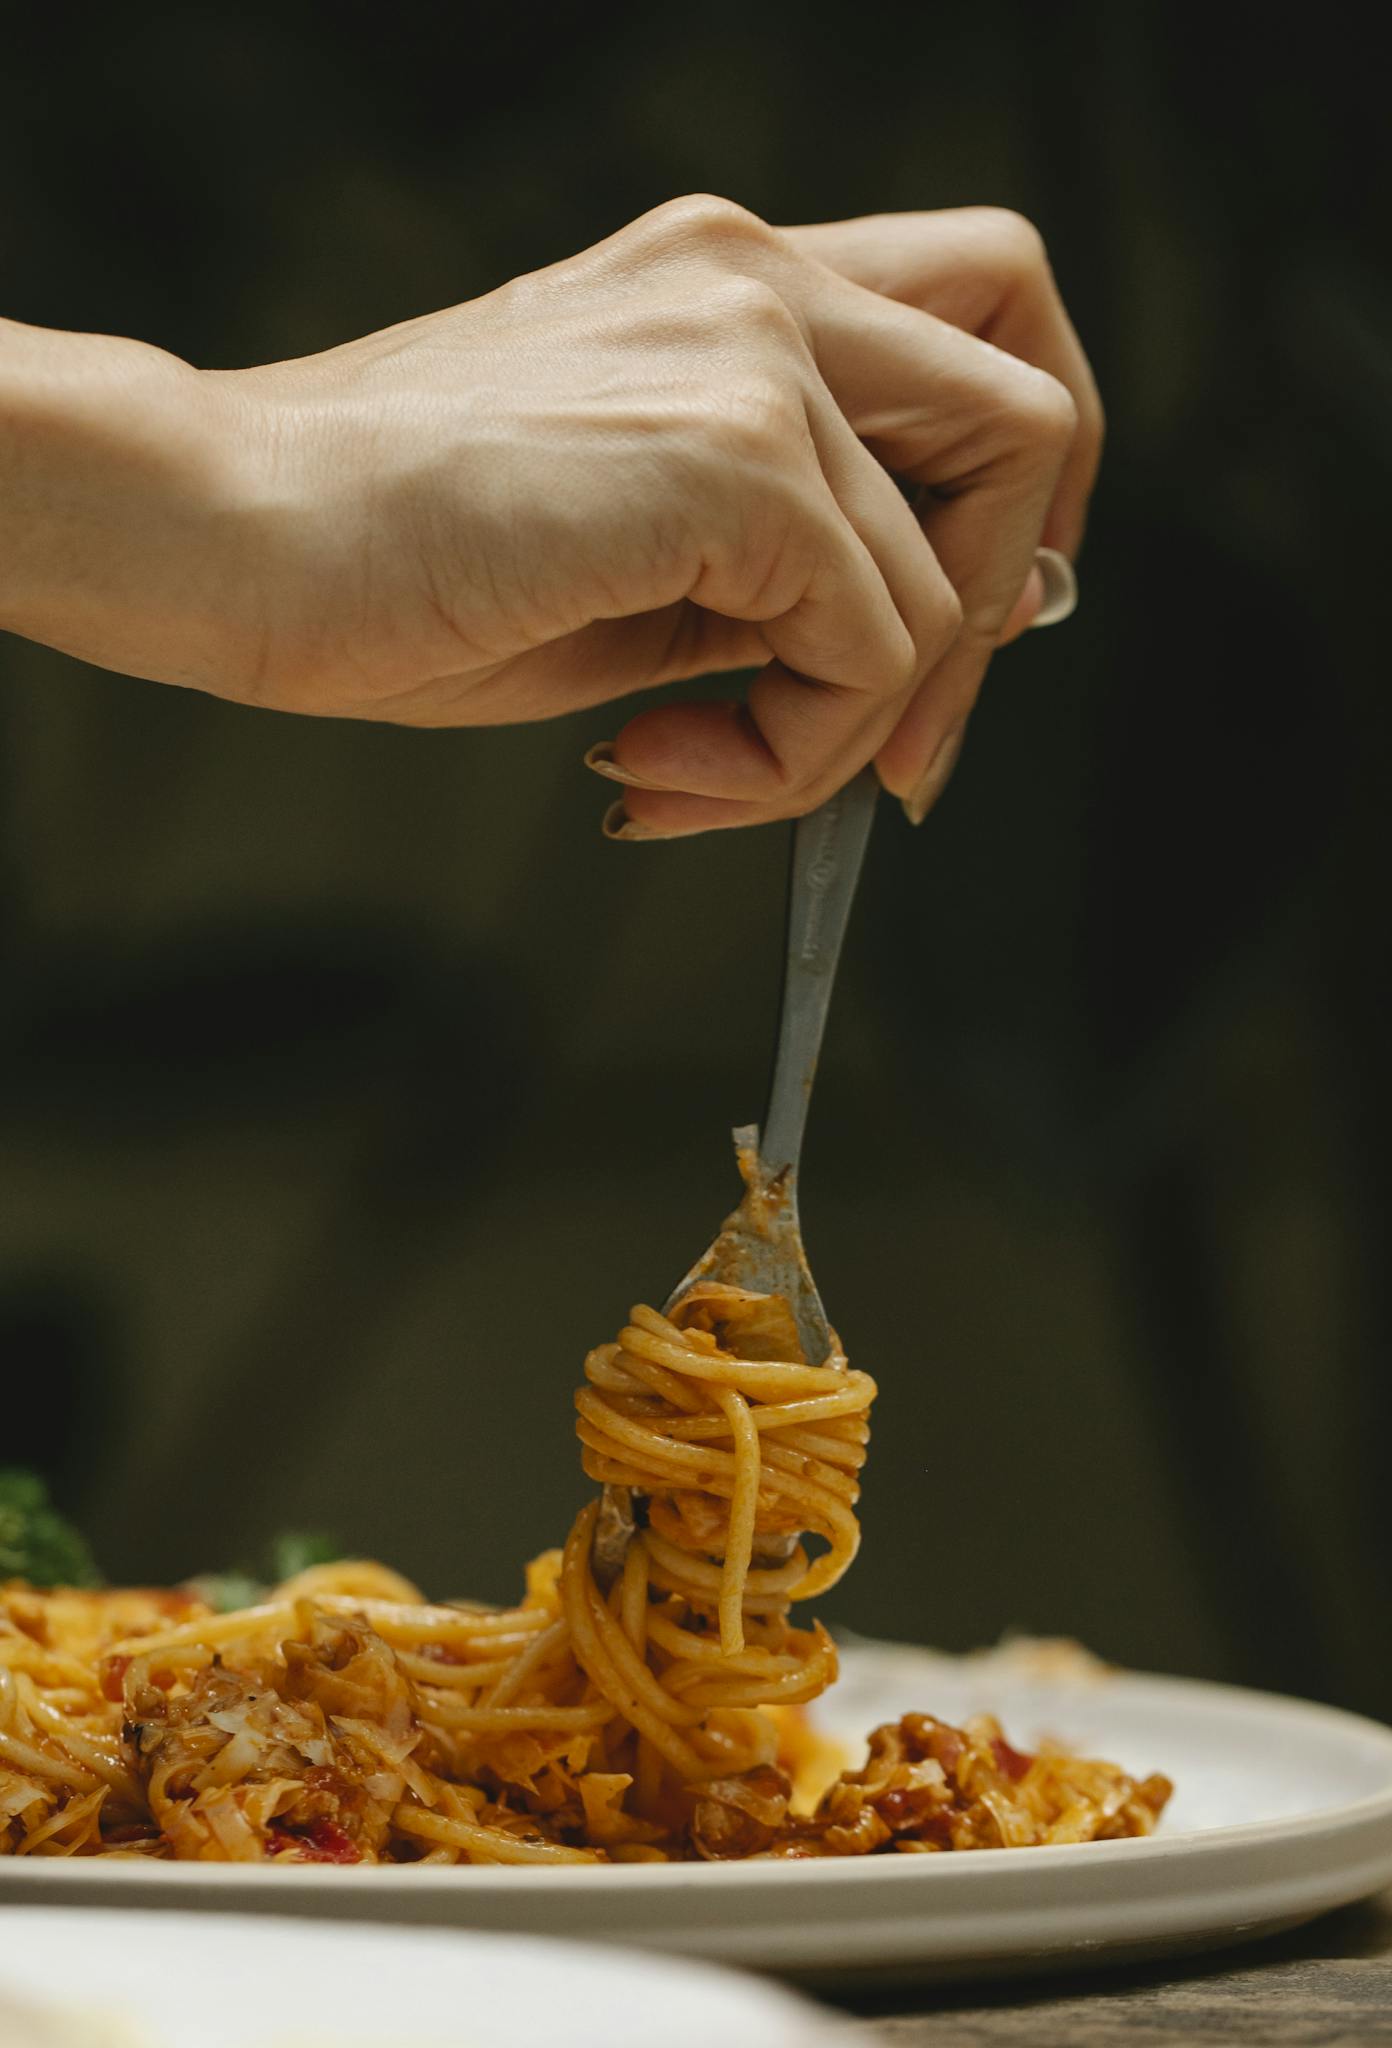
[784,207,1105,559]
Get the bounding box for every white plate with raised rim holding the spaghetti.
[0,1645,1392,1978]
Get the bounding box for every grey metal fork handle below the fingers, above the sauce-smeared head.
[759,768,880,1176]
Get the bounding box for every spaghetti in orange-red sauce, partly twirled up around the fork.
[0,1282,1169,1864]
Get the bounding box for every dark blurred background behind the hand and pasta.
[0,0,1392,1714]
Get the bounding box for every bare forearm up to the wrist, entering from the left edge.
[0,322,235,684]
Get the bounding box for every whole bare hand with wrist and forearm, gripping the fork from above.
[0,197,1101,838]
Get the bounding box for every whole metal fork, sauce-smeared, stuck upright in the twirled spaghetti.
[594,768,880,1583]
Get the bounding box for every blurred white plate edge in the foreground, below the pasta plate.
[0,1909,841,2048]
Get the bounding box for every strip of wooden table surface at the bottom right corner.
[827,1890,1392,2048]
